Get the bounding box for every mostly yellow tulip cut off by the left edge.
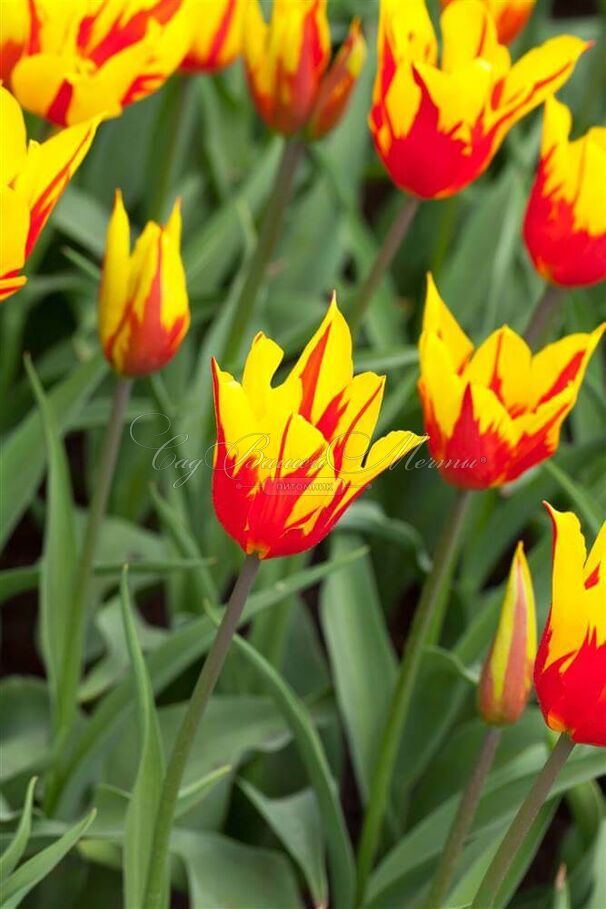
[0,86,97,300]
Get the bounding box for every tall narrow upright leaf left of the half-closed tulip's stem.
[25,357,80,729]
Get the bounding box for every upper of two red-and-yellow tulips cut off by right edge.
[524,98,606,287]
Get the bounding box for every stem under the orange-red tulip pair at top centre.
[223,138,305,365]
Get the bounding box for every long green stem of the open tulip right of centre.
[358,490,471,905]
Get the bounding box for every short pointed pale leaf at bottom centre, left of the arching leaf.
[238,780,328,906]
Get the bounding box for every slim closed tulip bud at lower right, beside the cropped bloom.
[478,543,537,726]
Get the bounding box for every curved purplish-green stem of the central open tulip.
[143,556,260,909]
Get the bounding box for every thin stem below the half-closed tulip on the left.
[47,379,132,811]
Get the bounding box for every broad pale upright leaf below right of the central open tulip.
[320,534,396,801]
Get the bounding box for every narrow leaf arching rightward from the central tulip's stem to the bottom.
[233,634,355,909]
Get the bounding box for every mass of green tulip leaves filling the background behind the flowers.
[0,0,606,909]
